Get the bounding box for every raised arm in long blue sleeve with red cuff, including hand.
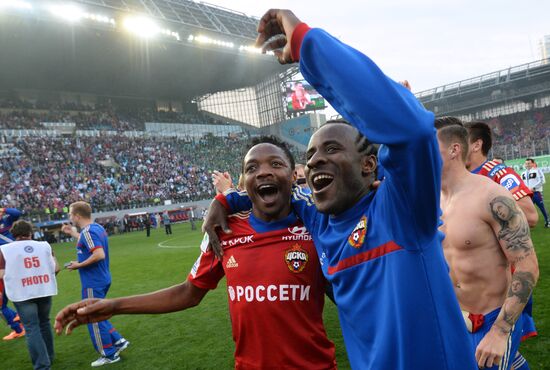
[257,10,441,244]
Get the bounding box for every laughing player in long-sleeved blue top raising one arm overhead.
[206,10,477,370]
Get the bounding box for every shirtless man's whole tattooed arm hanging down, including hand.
[476,194,539,368]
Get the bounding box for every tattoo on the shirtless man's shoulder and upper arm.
[490,196,533,253]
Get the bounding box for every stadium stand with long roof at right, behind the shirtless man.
[416,59,550,161]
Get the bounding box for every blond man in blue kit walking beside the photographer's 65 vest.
[61,202,130,367]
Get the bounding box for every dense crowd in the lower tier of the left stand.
[0,135,262,213]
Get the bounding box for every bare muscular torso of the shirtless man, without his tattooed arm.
[440,173,511,314]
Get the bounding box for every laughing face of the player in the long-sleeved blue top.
[306,123,376,215]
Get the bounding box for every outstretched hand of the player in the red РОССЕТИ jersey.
[54,298,115,335]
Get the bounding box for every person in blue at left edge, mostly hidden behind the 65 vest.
[0,208,25,340]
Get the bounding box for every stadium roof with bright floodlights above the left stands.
[0,0,285,100]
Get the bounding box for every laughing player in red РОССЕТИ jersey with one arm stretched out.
[55,138,336,369]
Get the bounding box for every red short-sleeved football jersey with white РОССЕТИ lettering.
[188,213,336,369]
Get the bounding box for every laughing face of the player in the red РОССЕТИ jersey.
[243,143,295,221]
